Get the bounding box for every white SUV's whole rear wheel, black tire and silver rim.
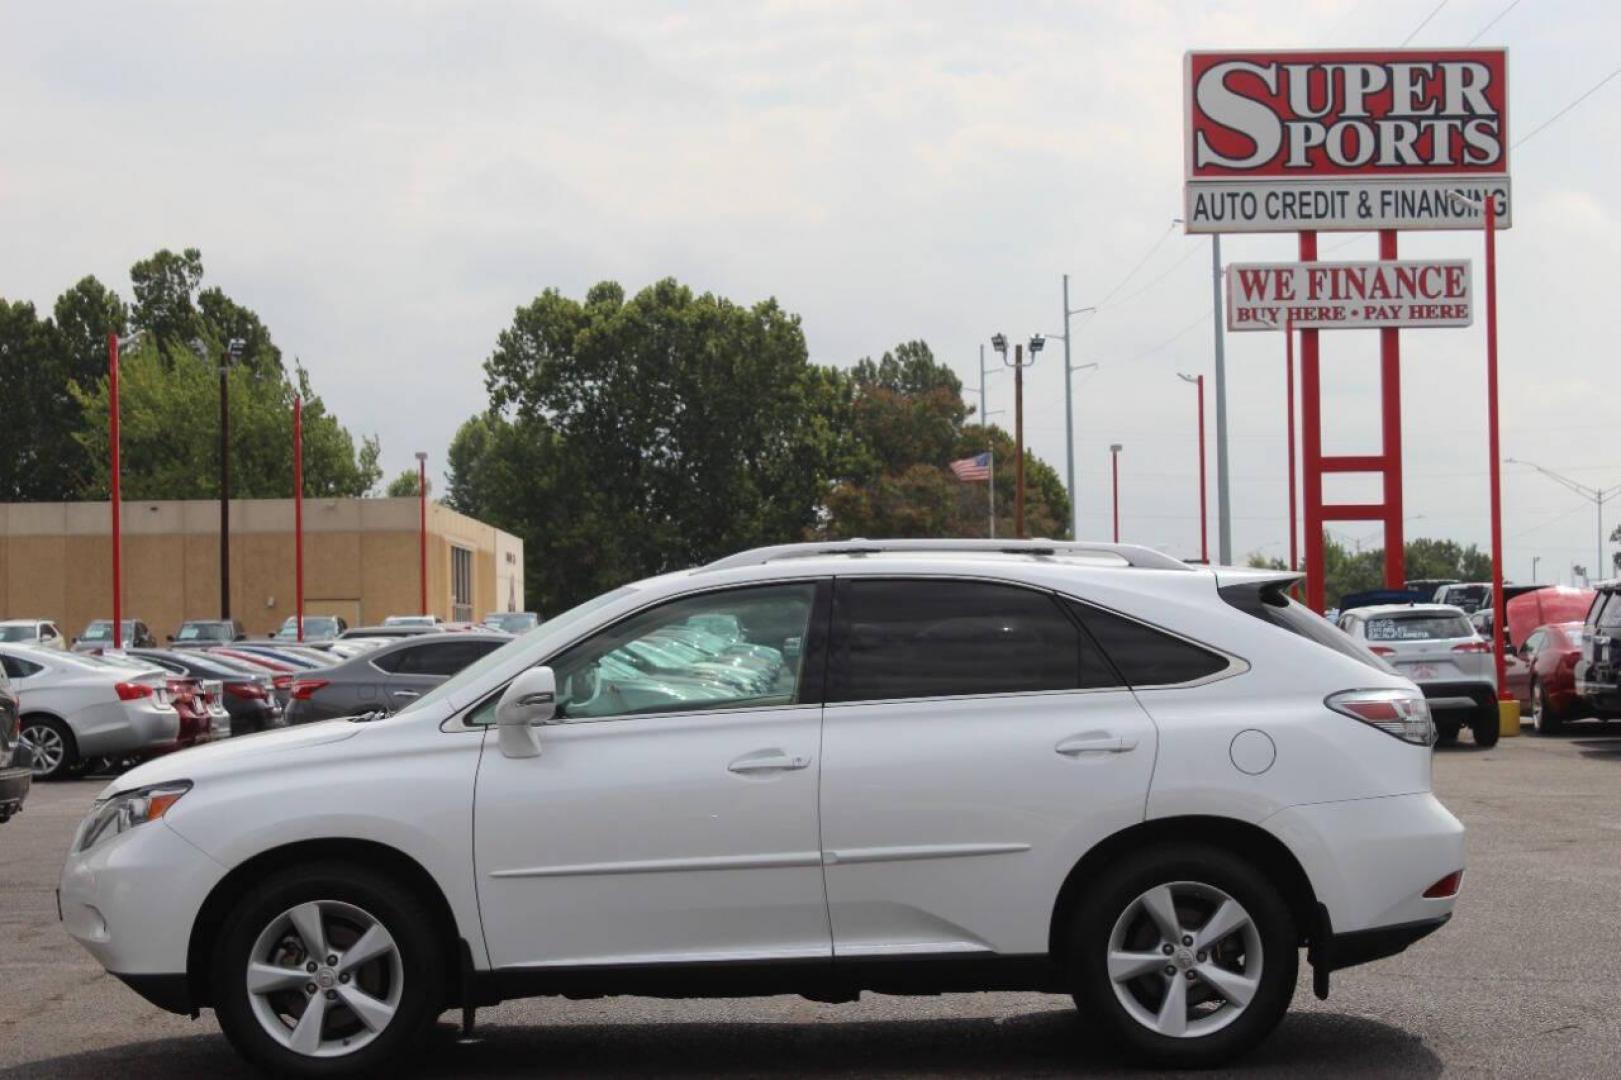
[1068,846,1300,1069]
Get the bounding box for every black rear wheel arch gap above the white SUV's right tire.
[1047,816,1321,958]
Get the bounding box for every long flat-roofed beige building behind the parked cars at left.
[0,498,524,641]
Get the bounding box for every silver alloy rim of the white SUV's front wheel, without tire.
[245,900,405,1057]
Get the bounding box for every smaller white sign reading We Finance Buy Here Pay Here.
[1227,259,1475,331]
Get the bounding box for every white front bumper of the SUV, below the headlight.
[58,810,225,981]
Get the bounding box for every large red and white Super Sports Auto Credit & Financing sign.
[1183,49,1511,232]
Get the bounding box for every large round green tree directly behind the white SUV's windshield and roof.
[476,279,841,610]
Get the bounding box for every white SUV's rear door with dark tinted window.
[822,577,1157,958]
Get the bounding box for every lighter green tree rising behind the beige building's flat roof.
[73,341,383,499]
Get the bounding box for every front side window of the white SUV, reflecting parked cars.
[551,582,817,720]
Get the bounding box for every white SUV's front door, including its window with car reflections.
[470,581,832,966]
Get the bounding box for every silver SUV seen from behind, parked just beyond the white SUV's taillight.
[1339,603,1499,746]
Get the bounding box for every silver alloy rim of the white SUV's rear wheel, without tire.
[1109,881,1263,1038]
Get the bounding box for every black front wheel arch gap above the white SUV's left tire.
[186,838,467,1010]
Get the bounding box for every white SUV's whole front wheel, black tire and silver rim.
[212,863,444,1077]
